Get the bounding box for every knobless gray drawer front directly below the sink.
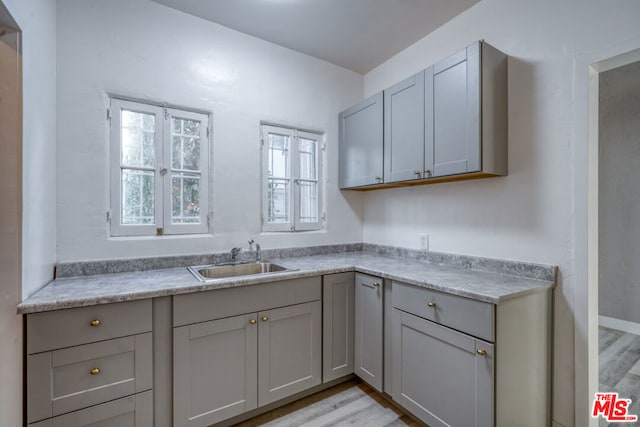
[173,276,322,327]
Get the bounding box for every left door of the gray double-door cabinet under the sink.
[173,313,258,427]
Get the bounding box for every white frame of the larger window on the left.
[109,97,210,237]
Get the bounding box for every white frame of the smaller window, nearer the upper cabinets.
[261,124,325,232]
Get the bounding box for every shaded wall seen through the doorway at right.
[598,62,640,323]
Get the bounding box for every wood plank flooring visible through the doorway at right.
[598,326,640,427]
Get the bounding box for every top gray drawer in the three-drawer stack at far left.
[27,299,152,354]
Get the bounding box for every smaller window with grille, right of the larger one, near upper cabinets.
[262,125,324,231]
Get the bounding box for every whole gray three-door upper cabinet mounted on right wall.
[340,41,508,190]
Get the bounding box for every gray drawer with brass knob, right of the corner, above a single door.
[392,282,495,341]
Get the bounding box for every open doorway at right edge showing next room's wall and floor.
[598,57,640,415]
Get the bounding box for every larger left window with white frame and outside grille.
[110,98,209,236]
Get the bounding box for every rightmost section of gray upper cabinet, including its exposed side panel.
[425,42,507,178]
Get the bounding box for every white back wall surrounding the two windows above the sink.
[57,0,363,261]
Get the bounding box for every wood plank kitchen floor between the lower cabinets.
[235,380,423,427]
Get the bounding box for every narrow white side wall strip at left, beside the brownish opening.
[17,0,57,298]
